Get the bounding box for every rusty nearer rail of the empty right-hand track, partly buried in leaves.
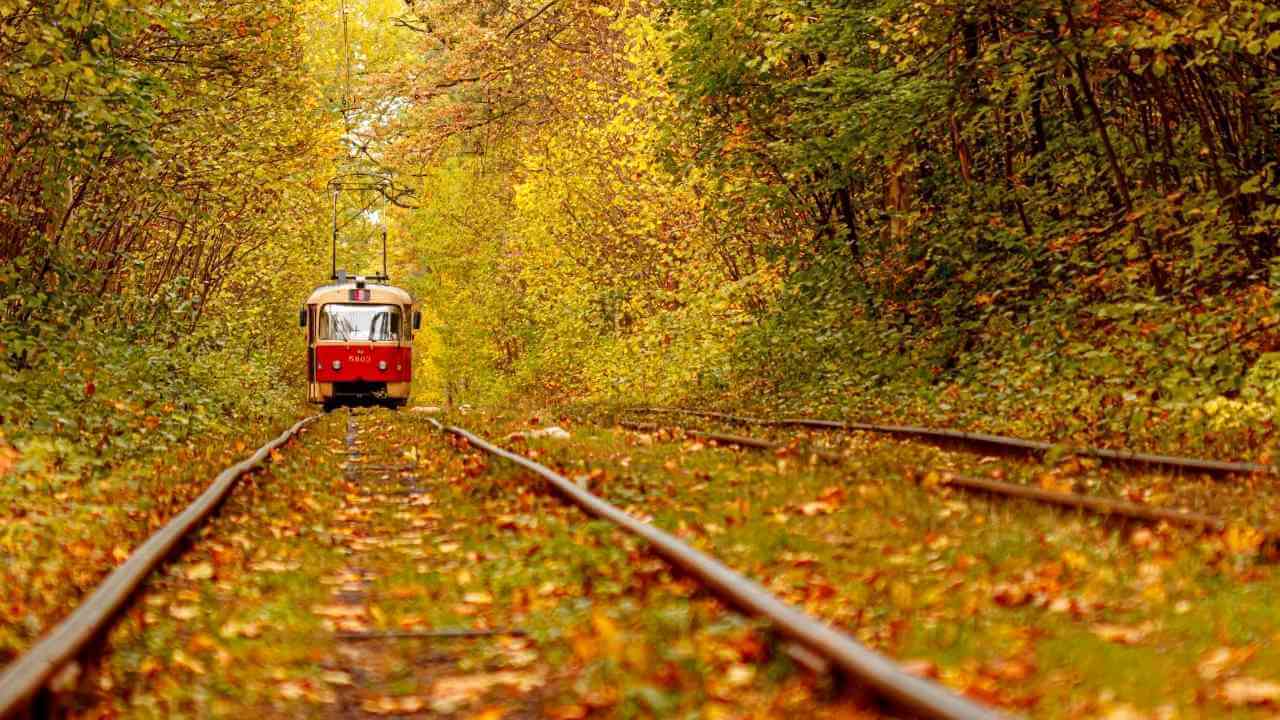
[629,421,1239,530]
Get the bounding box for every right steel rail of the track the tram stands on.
[429,418,1004,720]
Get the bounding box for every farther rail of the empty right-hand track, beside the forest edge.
[635,407,1280,475]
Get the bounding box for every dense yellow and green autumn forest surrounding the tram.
[0,0,1280,476]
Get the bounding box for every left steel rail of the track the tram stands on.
[0,415,320,719]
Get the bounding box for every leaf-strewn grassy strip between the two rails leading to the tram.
[49,411,844,717]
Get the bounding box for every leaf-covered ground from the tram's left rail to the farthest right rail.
[12,410,1280,719]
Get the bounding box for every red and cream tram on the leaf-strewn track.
[298,272,422,410]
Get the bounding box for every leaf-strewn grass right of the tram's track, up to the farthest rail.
[494,407,1280,717]
